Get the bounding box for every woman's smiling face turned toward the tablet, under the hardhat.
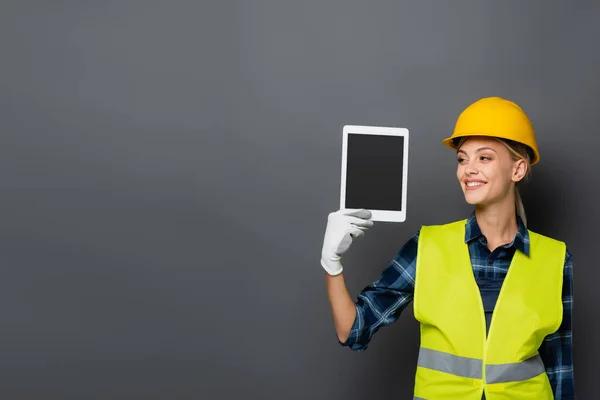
[456,136,527,205]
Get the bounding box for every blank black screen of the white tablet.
[345,133,404,211]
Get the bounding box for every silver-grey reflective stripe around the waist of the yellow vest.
[417,347,545,384]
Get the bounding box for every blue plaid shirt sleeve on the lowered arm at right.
[539,250,575,400]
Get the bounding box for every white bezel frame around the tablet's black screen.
[340,125,408,222]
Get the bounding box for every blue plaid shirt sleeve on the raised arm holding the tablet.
[338,232,419,351]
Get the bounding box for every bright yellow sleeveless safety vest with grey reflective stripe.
[413,220,566,400]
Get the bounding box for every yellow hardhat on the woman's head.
[442,97,540,165]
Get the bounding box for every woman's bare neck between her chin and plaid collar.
[475,201,519,249]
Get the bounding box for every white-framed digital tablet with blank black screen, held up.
[340,125,408,222]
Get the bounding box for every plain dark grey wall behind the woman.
[0,0,600,399]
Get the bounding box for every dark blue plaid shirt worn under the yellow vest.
[340,213,575,400]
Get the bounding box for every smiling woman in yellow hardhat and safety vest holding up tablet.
[321,97,575,400]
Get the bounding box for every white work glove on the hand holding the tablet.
[321,209,373,275]
